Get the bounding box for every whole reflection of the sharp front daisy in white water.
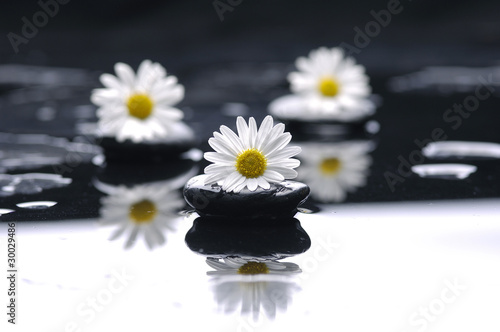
[207,258,301,320]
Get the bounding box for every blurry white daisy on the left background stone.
[91,60,184,143]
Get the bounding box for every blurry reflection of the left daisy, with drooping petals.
[100,182,184,249]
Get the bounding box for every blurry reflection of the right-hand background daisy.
[298,141,373,202]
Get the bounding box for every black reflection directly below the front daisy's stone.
[186,217,311,259]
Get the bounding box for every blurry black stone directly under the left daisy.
[100,137,195,162]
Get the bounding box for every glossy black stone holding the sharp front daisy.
[184,175,309,219]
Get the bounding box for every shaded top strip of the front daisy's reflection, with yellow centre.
[207,257,302,276]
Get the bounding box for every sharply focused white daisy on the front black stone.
[204,116,300,193]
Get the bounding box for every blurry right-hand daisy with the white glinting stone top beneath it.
[269,47,375,122]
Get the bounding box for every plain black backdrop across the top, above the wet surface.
[0,0,500,72]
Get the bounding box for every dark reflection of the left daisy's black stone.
[97,157,196,186]
